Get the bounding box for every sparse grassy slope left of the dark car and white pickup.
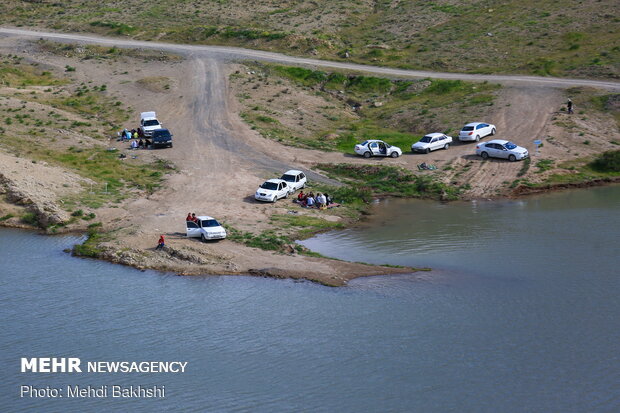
[0,56,173,210]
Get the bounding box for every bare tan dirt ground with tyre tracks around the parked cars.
[0,32,609,285]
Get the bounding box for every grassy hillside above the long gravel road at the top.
[0,0,620,78]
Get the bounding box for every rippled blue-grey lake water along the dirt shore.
[0,186,620,412]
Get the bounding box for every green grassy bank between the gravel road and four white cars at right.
[234,65,499,152]
